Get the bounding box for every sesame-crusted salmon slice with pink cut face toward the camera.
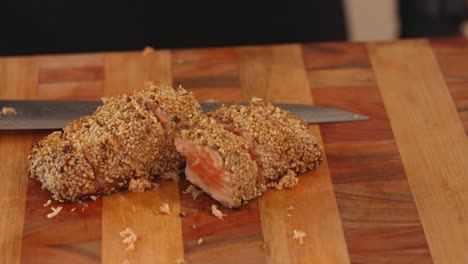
[175,115,263,208]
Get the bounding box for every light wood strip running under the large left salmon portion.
[102,50,183,263]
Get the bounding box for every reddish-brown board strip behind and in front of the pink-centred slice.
[172,48,266,264]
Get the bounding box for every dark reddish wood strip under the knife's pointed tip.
[304,43,431,263]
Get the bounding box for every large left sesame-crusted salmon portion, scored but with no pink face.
[30,85,200,201]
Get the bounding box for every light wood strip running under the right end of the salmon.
[238,45,349,263]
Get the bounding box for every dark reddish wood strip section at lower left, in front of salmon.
[21,154,102,263]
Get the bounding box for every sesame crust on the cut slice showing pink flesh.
[176,115,264,207]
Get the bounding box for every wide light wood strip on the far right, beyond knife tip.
[368,40,468,263]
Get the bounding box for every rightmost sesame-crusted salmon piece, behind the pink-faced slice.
[208,99,322,189]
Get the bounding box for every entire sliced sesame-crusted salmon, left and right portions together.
[29,83,322,208]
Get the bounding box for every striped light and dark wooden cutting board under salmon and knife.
[0,39,468,263]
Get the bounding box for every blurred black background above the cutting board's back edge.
[0,0,466,55]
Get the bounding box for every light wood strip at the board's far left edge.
[0,57,37,263]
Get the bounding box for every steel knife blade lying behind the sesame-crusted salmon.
[0,100,368,130]
